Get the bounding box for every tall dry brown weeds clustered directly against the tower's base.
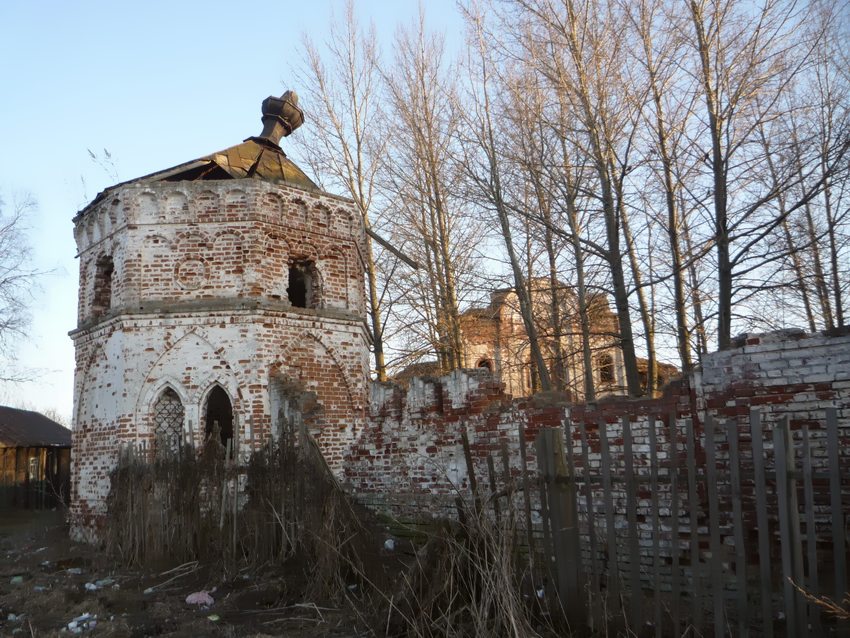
[106,430,366,600]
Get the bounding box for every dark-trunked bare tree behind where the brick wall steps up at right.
[688,0,819,348]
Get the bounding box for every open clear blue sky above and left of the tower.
[0,0,462,424]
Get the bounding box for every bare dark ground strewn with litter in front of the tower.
[0,511,380,638]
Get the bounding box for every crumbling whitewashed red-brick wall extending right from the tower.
[343,332,850,600]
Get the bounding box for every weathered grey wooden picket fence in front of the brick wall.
[520,408,850,638]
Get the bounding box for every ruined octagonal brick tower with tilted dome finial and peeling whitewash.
[71,92,368,538]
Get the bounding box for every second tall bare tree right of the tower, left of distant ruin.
[384,13,477,370]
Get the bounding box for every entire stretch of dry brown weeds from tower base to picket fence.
[107,437,568,638]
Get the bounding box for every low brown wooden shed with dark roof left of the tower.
[0,406,71,509]
